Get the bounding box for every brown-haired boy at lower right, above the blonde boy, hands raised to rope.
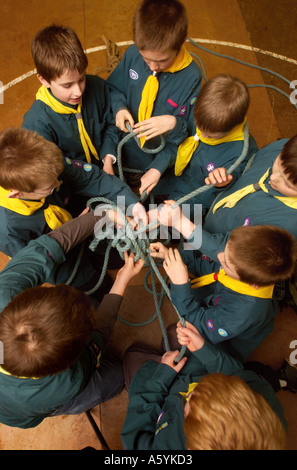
[151,225,297,362]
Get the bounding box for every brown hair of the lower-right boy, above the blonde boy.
[228,225,297,287]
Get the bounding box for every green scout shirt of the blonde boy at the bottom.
[121,342,287,451]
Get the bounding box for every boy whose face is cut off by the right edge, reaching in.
[150,135,297,261]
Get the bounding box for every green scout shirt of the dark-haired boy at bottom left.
[0,235,104,428]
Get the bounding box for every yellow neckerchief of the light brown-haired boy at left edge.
[0,186,72,230]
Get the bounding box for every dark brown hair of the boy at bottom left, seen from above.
[0,284,94,378]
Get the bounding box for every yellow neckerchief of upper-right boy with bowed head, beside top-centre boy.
[174,118,246,176]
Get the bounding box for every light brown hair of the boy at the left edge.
[0,127,64,193]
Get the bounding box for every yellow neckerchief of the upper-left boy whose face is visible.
[36,85,99,163]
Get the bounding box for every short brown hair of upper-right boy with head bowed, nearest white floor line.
[193,74,250,133]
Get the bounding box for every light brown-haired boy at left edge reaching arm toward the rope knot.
[0,128,145,291]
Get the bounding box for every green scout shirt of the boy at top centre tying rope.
[107,45,202,173]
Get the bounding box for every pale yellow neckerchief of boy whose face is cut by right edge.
[212,168,297,214]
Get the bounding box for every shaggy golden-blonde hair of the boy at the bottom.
[184,373,286,450]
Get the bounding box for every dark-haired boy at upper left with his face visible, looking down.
[23,25,119,174]
